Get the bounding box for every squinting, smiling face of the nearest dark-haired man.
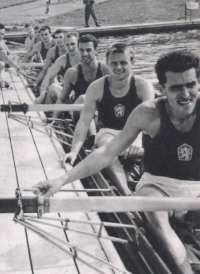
[163,68,199,118]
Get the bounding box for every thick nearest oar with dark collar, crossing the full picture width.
[0,195,200,213]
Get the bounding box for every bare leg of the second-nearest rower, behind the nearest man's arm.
[96,133,132,196]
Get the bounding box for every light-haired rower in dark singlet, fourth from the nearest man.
[35,32,80,104]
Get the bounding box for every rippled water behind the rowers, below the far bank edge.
[11,29,200,79]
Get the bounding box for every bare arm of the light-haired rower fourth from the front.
[40,56,66,94]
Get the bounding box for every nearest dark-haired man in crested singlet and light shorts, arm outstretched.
[36,50,200,274]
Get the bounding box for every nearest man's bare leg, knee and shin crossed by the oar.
[137,187,193,274]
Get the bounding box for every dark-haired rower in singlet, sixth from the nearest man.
[27,26,56,62]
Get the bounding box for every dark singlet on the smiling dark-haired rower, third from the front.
[73,62,103,100]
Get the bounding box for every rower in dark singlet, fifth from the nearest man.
[35,29,67,87]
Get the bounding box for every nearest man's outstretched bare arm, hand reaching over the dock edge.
[35,103,149,196]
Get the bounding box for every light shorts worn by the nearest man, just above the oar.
[136,172,200,197]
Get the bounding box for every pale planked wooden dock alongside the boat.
[0,67,130,274]
